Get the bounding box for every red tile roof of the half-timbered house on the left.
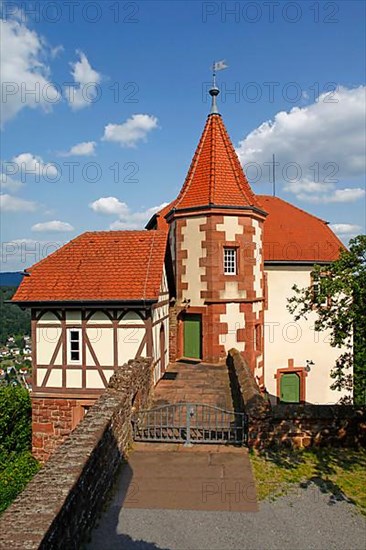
[13,231,166,302]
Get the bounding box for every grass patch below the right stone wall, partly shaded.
[250,448,366,515]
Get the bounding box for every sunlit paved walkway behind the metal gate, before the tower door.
[153,363,233,411]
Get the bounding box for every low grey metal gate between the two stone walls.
[132,403,248,446]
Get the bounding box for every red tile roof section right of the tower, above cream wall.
[258,195,345,262]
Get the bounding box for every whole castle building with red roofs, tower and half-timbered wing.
[13,82,343,458]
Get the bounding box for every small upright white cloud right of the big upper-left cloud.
[65,51,102,111]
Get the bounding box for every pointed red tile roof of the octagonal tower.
[174,114,259,209]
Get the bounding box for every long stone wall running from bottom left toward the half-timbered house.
[0,359,153,550]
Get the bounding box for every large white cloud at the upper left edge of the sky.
[0,13,60,125]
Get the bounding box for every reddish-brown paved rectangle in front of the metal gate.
[103,443,257,512]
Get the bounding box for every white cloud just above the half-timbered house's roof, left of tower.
[89,197,168,230]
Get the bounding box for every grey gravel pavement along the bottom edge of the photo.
[87,485,366,550]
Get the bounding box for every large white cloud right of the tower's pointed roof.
[237,86,366,203]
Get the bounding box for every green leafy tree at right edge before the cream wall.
[287,235,366,405]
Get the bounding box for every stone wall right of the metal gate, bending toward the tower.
[228,349,366,449]
